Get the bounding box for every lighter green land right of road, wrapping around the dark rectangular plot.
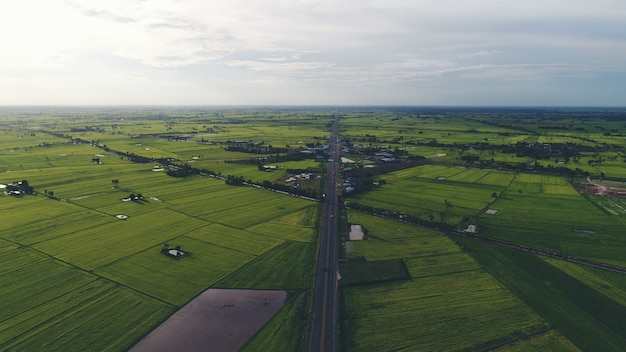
[341,213,576,351]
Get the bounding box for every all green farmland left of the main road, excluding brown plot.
[0,108,326,351]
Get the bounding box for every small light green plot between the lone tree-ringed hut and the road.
[186,224,283,255]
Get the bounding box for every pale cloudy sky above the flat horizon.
[0,0,626,106]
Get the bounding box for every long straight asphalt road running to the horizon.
[308,113,340,352]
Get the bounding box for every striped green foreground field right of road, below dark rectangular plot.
[346,271,546,351]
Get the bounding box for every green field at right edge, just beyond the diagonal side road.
[478,174,626,265]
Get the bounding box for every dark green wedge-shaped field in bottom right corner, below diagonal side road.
[459,239,626,351]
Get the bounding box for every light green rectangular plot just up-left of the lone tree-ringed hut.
[34,209,206,269]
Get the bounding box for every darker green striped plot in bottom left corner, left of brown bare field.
[0,249,172,351]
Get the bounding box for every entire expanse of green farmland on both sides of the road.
[0,107,626,351]
